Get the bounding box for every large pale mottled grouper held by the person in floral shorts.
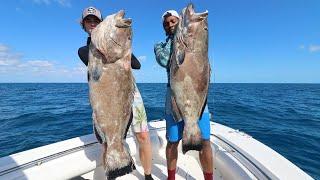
[88,10,135,179]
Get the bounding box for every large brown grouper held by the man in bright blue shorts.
[170,4,210,153]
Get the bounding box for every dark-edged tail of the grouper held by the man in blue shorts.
[182,123,202,154]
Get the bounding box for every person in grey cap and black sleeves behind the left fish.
[78,7,153,180]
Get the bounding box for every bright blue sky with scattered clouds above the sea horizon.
[0,0,320,83]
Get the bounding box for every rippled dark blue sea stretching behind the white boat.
[0,83,320,179]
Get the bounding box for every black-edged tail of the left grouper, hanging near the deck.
[104,143,136,179]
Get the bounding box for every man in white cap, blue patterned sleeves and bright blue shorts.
[154,10,213,180]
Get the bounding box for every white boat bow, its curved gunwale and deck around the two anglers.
[0,121,312,180]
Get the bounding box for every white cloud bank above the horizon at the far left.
[0,44,87,82]
